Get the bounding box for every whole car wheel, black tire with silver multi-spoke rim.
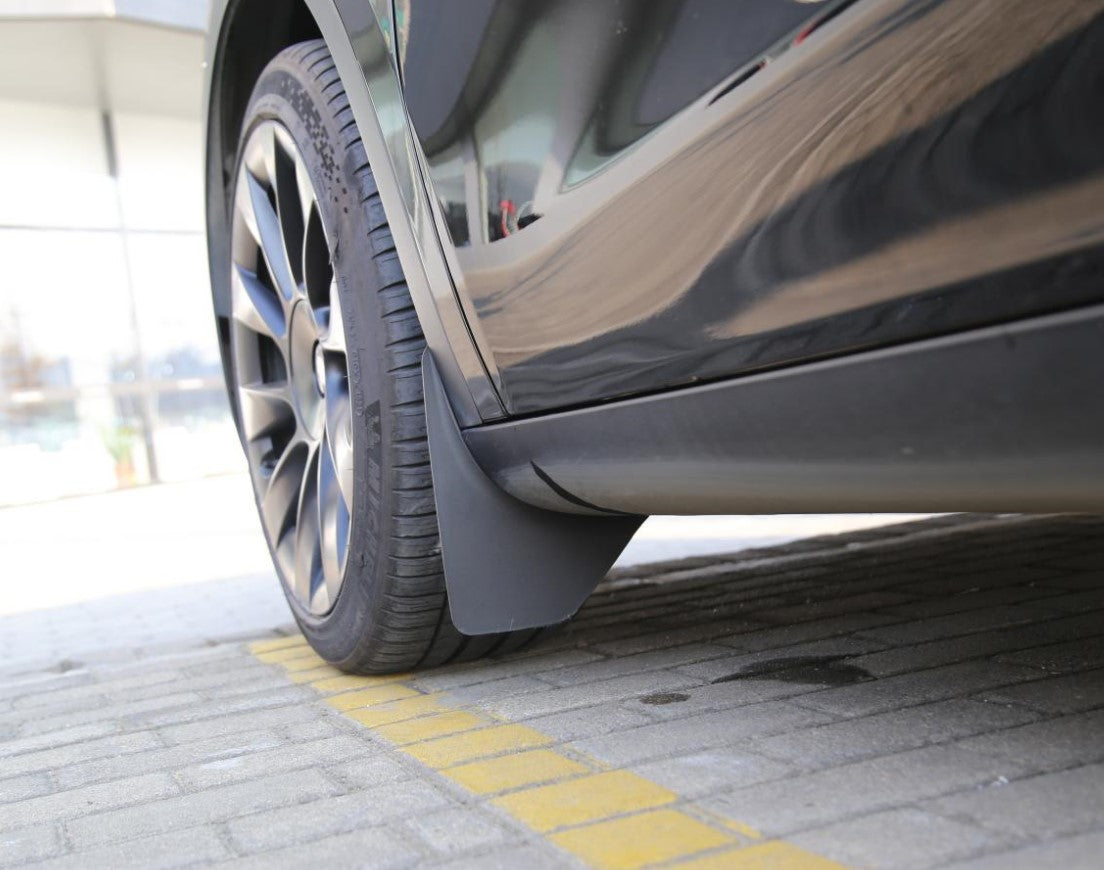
[230,40,539,673]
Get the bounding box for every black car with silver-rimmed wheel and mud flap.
[205,0,1104,671]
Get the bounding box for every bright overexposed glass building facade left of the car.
[0,0,242,505]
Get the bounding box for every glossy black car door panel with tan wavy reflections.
[396,0,1104,414]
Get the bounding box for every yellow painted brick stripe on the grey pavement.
[250,636,841,870]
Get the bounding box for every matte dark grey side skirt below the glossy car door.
[464,305,1104,514]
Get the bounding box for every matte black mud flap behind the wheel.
[422,350,645,635]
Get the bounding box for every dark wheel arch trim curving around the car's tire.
[203,0,505,435]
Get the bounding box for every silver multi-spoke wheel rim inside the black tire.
[231,121,354,615]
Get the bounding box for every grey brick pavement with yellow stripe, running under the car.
[0,516,1104,868]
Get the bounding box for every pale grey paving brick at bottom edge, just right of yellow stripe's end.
[789,807,1001,870]
